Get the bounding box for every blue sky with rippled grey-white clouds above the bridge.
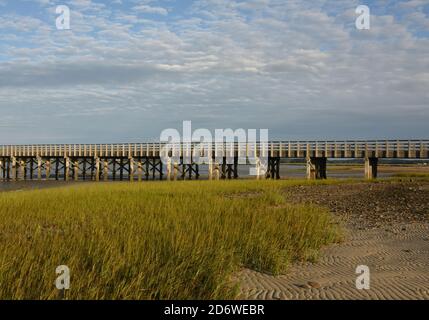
[0,0,429,144]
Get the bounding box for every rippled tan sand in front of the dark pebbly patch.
[237,223,429,300]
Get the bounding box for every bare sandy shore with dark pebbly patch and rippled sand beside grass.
[237,182,429,299]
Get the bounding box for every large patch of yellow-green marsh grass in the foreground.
[0,181,339,299]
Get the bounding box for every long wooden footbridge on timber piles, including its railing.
[0,140,429,181]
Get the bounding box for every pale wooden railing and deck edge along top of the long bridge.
[0,140,429,158]
